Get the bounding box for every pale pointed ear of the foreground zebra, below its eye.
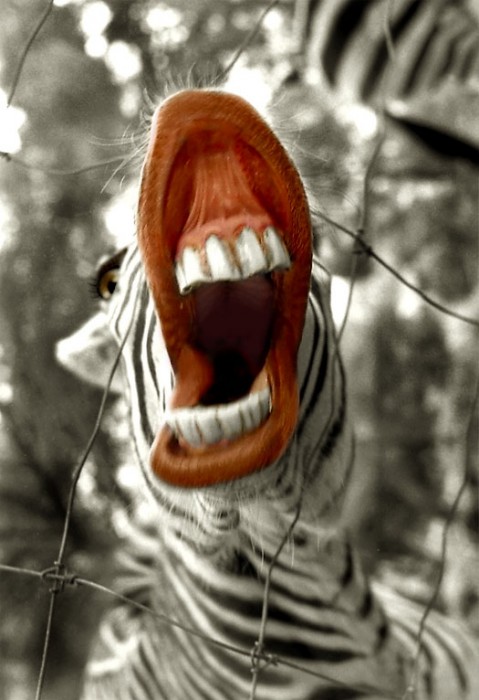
[55,311,124,394]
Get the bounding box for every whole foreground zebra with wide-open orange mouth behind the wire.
[60,89,479,700]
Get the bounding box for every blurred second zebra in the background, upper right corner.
[283,0,479,153]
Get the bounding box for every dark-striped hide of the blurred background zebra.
[304,0,479,106]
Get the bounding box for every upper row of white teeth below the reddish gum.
[176,226,291,294]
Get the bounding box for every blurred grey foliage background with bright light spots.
[0,0,479,700]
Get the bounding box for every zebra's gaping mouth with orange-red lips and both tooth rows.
[138,90,311,487]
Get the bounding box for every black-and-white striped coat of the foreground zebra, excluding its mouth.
[75,228,479,700]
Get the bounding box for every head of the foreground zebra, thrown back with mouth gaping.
[58,90,352,536]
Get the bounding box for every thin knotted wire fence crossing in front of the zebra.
[0,0,479,700]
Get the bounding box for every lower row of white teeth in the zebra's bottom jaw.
[165,388,270,447]
